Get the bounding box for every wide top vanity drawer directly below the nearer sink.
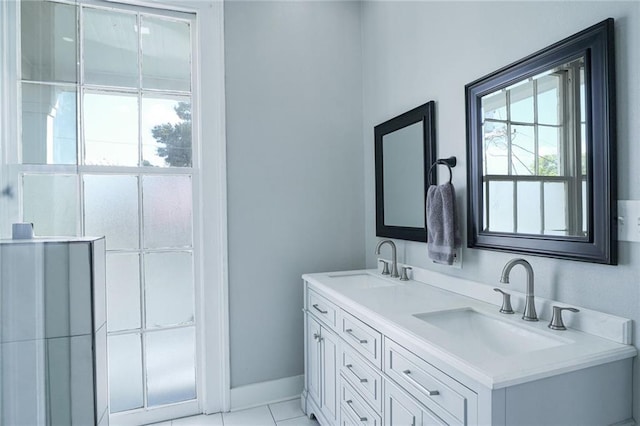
[384,339,477,424]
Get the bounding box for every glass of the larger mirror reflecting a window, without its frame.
[481,57,589,237]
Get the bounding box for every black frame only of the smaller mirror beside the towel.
[374,101,437,243]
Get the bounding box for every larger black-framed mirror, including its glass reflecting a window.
[466,19,617,264]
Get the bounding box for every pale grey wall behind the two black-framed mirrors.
[362,1,640,420]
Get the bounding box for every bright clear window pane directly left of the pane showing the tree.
[84,92,138,166]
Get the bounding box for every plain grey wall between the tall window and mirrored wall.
[225,1,365,387]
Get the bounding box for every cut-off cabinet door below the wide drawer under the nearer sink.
[384,381,446,426]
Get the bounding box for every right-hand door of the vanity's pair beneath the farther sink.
[320,327,339,423]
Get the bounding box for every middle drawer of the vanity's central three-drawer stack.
[340,345,382,412]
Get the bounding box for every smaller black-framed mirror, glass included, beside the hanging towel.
[374,101,436,242]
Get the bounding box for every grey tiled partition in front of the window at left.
[0,238,109,426]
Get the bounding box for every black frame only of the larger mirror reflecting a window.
[465,18,617,264]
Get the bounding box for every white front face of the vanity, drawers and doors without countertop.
[303,284,462,426]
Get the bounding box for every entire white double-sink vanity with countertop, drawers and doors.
[302,271,636,426]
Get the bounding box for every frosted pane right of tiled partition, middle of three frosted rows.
[107,253,140,332]
